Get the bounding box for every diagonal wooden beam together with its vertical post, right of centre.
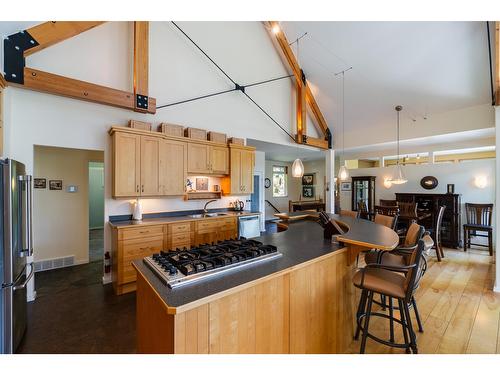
[268,21,328,148]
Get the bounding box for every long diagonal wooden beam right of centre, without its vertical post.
[268,21,328,136]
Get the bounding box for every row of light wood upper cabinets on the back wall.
[110,127,255,198]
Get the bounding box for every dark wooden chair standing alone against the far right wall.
[464,203,493,255]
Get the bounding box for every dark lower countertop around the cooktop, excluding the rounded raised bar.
[133,220,343,313]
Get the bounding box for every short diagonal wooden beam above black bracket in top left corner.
[24,21,104,57]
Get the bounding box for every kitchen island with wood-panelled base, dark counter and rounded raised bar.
[133,214,398,353]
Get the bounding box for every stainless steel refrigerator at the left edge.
[0,159,34,353]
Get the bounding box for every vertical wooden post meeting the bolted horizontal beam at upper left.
[134,21,149,112]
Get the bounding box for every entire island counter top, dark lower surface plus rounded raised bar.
[133,212,399,313]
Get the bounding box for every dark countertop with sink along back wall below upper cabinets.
[109,210,260,228]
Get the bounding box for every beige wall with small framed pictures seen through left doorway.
[33,147,104,264]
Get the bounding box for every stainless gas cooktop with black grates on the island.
[144,237,282,288]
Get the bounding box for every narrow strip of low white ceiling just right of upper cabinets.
[247,138,325,162]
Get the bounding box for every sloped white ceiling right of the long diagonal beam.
[281,22,494,147]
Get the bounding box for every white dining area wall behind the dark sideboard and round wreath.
[340,159,495,228]
